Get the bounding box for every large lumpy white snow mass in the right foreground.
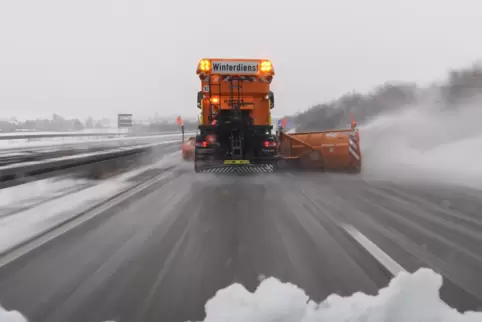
[191,269,482,322]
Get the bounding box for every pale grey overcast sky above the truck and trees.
[0,0,482,118]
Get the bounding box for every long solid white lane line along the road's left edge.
[0,170,179,267]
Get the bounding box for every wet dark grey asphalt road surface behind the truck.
[0,166,482,322]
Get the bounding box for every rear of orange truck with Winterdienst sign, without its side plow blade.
[194,59,278,173]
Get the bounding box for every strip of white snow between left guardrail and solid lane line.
[0,152,180,254]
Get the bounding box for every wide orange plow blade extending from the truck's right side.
[279,129,361,172]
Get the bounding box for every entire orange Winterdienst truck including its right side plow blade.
[194,58,361,173]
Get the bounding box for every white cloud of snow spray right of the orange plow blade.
[360,98,482,186]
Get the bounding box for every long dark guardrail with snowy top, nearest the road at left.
[0,140,180,189]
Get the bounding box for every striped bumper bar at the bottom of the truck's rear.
[195,160,276,175]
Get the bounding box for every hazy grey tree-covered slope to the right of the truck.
[288,60,482,131]
